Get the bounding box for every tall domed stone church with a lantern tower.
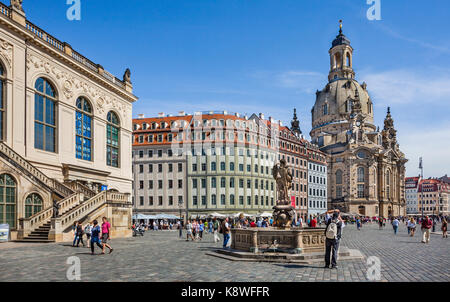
[310,25,407,217]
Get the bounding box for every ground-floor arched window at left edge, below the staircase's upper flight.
[0,174,17,228]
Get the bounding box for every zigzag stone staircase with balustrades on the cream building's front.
[0,142,131,242]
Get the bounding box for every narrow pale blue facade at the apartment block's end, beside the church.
[307,143,328,218]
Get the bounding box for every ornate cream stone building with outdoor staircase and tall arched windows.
[0,1,137,241]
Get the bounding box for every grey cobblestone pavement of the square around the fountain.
[0,224,450,282]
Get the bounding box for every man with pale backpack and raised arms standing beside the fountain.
[325,210,343,268]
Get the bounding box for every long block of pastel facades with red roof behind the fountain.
[133,111,327,219]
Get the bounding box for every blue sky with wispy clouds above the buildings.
[20,0,450,176]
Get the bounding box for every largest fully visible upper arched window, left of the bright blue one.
[34,78,57,152]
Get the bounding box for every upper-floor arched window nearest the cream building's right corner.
[106,111,120,167]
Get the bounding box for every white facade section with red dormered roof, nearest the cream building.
[133,113,192,214]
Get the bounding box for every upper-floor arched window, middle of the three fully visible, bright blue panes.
[75,97,92,160]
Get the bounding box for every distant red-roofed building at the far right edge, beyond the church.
[417,178,450,215]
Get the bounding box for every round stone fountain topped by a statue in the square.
[208,159,361,262]
